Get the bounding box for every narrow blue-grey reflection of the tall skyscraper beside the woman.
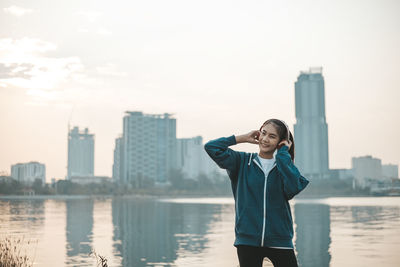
[294,204,331,267]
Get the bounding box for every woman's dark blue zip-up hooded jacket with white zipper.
[204,135,309,248]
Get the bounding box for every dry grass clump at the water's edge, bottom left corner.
[0,237,37,267]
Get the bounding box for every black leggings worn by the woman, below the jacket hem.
[236,245,298,267]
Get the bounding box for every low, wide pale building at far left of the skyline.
[11,161,46,184]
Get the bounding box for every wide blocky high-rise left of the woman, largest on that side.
[114,111,176,187]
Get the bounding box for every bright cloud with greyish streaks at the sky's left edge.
[0,38,84,90]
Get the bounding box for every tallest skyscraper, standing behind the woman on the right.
[294,68,329,179]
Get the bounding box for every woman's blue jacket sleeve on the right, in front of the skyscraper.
[275,146,309,200]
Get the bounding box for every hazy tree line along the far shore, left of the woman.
[0,170,231,195]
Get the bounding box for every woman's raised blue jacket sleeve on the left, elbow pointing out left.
[204,135,240,179]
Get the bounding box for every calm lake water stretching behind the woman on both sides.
[0,197,400,267]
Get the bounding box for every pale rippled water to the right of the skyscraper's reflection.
[331,205,400,267]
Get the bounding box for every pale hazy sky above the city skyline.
[0,0,400,181]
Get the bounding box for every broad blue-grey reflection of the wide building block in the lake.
[112,199,221,267]
